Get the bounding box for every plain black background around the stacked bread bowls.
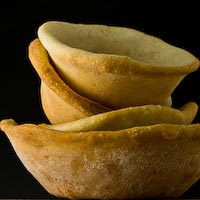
[0,0,200,198]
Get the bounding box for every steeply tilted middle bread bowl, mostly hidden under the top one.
[28,39,111,124]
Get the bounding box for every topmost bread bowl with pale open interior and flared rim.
[38,21,199,109]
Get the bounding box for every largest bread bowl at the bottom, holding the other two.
[0,103,200,199]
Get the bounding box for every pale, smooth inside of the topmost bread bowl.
[38,21,197,66]
